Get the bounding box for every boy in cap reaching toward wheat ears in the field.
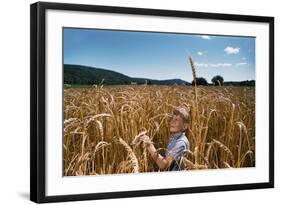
[140,108,189,171]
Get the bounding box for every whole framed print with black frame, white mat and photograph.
[30,2,274,203]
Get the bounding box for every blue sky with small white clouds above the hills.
[64,28,255,82]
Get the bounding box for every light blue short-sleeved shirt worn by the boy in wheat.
[165,132,189,171]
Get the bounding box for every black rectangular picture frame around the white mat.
[30,2,274,203]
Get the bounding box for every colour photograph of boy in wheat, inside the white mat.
[61,27,256,176]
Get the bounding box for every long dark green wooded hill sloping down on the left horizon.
[64,64,190,85]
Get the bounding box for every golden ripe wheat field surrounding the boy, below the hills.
[63,85,255,176]
